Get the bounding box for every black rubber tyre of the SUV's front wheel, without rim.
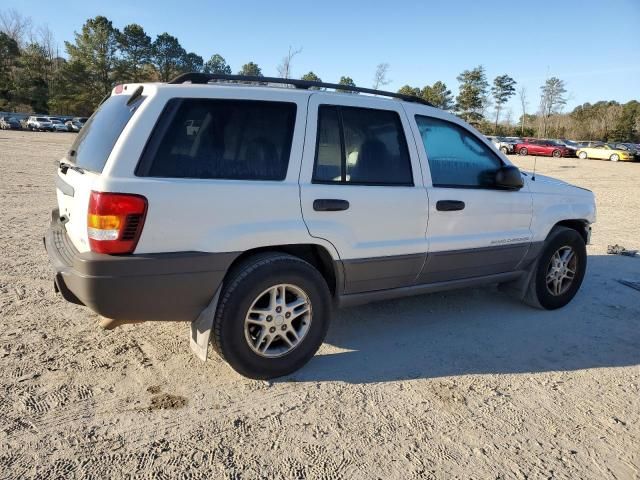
[535,228,587,310]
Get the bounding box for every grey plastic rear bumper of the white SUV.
[44,209,239,322]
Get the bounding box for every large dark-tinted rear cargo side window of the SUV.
[136,99,296,180]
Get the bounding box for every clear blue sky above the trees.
[6,0,640,119]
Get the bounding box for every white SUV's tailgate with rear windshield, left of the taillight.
[56,89,144,252]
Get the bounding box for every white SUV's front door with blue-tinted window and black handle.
[406,109,533,283]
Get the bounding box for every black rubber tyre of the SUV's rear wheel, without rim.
[213,254,331,379]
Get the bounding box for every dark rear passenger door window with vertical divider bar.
[313,105,413,186]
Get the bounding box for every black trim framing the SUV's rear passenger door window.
[311,103,415,187]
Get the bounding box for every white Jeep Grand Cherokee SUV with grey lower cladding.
[45,74,596,378]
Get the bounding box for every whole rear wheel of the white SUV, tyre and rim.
[212,253,332,379]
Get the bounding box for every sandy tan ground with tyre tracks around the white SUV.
[0,132,640,479]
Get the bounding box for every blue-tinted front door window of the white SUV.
[416,115,502,188]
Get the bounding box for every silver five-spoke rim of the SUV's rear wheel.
[244,284,312,358]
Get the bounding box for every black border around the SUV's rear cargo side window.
[134,97,298,183]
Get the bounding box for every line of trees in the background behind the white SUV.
[0,10,640,141]
